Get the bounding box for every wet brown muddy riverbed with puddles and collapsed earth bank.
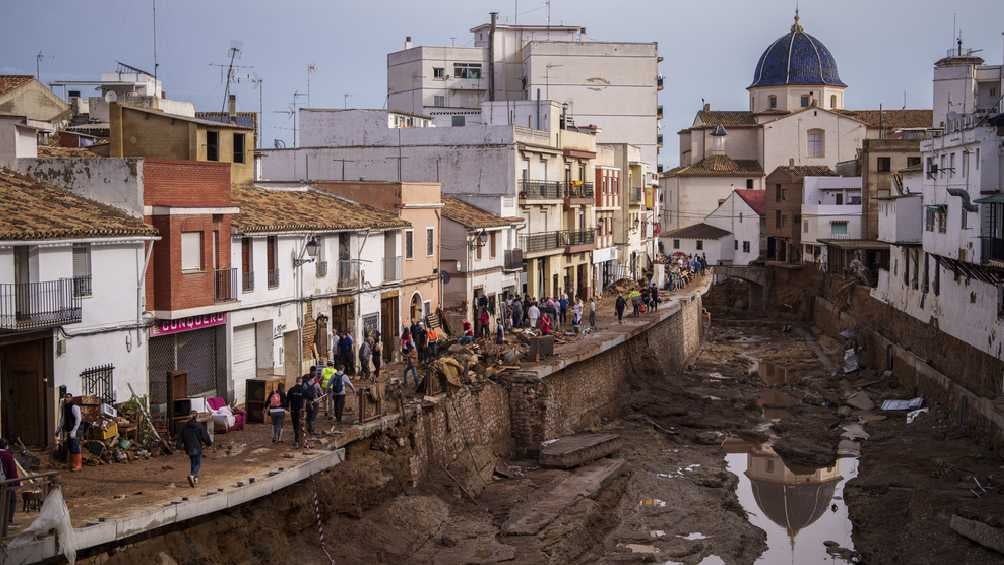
[88,319,1004,565]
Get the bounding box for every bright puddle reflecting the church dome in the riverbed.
[725,446,857,565]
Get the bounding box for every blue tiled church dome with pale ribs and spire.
[750,14,846,87]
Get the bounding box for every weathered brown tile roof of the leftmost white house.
[0,169,159,241]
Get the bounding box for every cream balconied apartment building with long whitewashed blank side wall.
[261,101,596,296]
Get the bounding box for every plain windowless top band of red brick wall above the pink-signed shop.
[143,159,233,208]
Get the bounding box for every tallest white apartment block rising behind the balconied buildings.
[387,14,664,171]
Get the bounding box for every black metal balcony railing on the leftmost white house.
[0,277,83,331]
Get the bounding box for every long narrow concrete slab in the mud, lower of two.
[502,459,622,536]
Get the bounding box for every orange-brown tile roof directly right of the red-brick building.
[232,186,411,234]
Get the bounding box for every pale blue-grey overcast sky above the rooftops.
[0,0,1004,166]
